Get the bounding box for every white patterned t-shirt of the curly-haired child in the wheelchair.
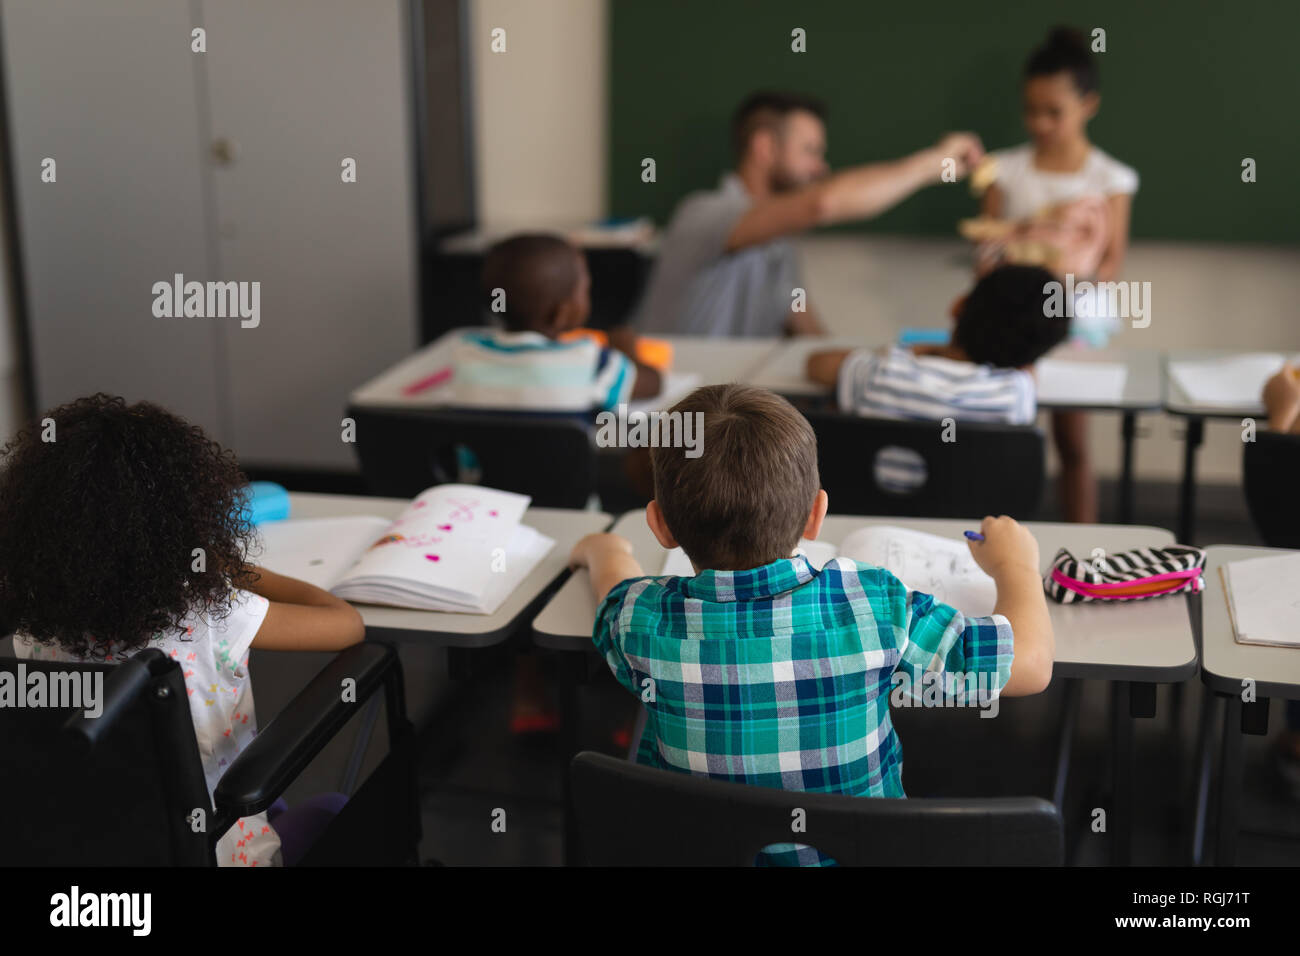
[13,591,281,866]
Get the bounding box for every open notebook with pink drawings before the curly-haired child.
[259,485,555,614]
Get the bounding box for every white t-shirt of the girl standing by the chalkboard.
[992,143,1138,219]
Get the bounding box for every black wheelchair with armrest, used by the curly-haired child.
[0,644,420,866]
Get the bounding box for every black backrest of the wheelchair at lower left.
[0,649,216,866]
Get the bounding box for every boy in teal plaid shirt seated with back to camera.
[569,385,1054,861]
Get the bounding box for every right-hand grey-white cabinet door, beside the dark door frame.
[202,0,417,468]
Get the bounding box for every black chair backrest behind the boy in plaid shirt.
[569,752,1065,866]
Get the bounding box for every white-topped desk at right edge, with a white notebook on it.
[1192,545,1300,866]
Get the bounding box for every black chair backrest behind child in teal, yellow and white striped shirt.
[350,408,595,509]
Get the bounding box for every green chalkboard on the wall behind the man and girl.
[608,0,1300,243]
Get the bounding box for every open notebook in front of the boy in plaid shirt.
[662,524,997,618]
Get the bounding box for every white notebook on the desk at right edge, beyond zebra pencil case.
[1219,554,1300,648]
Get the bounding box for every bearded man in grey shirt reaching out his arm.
[636,92,983,337]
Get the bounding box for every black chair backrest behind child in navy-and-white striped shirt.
[803,411,1047,520]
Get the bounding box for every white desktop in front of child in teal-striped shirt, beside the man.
[350,326,780,411]
